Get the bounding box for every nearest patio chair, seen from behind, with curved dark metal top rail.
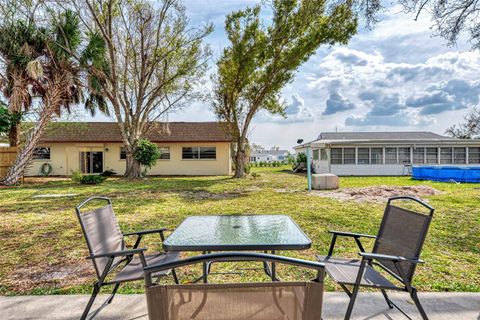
[144,252,324,320]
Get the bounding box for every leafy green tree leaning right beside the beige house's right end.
[212,0,357,178]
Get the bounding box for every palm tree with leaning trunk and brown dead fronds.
[0,11,108,185]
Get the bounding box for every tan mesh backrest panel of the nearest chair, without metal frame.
[146,282,323,320]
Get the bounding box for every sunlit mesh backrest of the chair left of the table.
[75,197,125,277]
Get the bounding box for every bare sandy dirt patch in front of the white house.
[312,185,442,202]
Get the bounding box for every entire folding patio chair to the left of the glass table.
[75,197,179,320]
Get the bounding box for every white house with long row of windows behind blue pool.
[294,132,480,176]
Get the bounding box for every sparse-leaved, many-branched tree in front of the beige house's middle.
[71,0,212,178]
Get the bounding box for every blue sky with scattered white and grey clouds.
[91,0,480,149]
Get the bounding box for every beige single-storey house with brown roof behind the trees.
[26,122,232,176]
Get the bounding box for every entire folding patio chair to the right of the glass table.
[318,197,435,319]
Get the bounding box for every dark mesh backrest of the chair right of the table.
[373,197,435,281]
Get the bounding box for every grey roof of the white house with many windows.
[318,131,448,140]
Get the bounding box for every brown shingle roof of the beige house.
[40,122,232,143]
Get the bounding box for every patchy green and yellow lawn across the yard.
[0,168,480,295]
